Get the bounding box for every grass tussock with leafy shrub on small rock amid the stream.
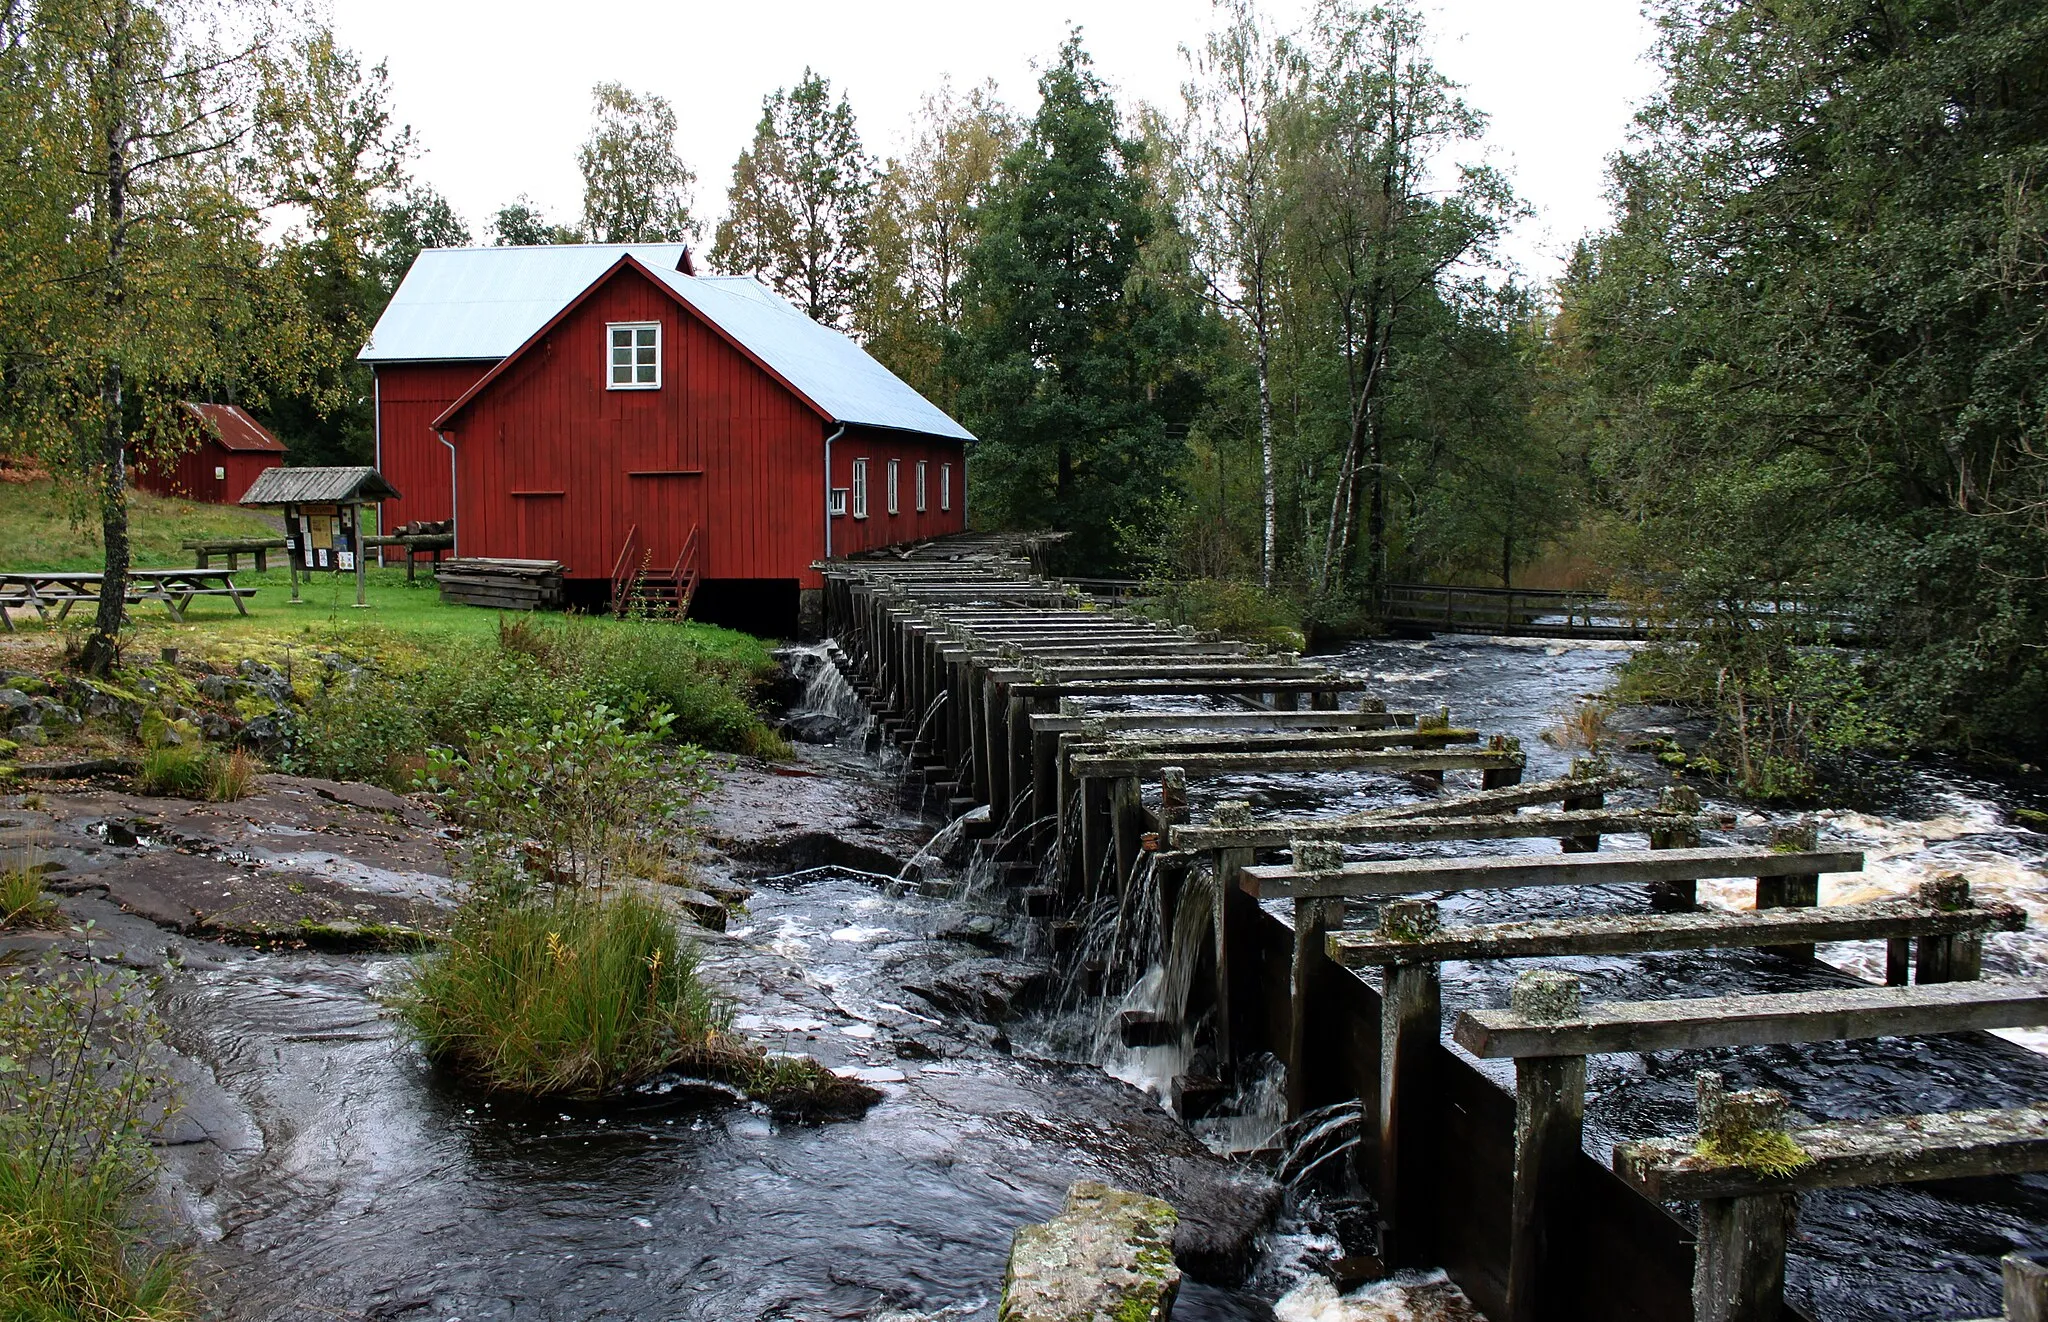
[395,692,879,1119]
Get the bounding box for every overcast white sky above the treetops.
[332,0,1655,278]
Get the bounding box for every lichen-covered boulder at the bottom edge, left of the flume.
[995,1181,1180,1322]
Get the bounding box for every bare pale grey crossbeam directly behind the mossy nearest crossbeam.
[1452,978,2048,1058]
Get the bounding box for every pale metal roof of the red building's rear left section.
[360,244,684,362]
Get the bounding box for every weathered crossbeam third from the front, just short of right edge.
[1329,900,2028,968]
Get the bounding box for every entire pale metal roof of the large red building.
[362,244,973,440]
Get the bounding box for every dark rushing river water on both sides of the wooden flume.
[166,641,2048,1322]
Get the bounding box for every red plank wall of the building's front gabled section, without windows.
[442,268,965,587]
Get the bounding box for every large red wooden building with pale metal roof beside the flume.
[362,244,973,632]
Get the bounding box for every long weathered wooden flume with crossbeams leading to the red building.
[821,536,2048,1322]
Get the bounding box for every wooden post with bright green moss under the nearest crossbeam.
[1692,1070,1798,1322]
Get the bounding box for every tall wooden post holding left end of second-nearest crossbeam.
[1507,970,1585,1322]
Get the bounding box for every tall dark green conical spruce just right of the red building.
[950,33,1202,565]
